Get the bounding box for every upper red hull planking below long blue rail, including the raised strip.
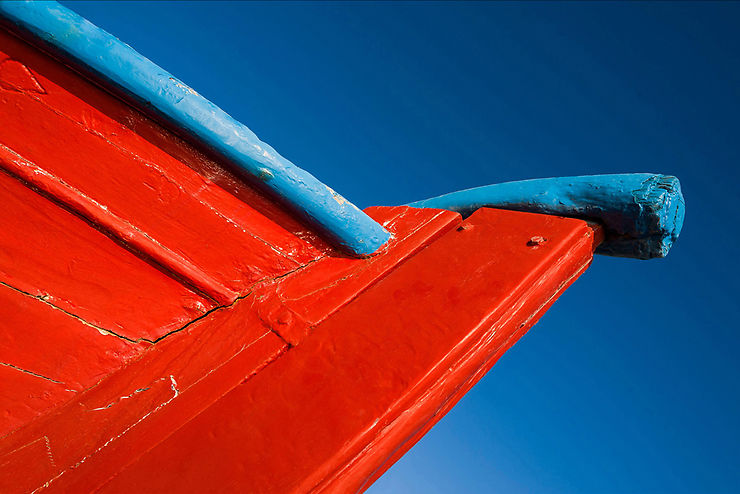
[0,31,326,303]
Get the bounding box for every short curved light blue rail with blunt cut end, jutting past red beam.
[410,173,684,259]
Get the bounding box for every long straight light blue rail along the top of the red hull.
[0,1,390,256]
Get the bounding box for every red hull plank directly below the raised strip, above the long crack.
[0,168,213,342]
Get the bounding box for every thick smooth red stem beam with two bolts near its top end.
[92,210,598,493]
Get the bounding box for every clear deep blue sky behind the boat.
[65,2,740,494]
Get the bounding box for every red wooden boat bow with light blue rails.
[0,2,684,493]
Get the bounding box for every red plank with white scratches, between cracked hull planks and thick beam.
[0,301,288,494]
